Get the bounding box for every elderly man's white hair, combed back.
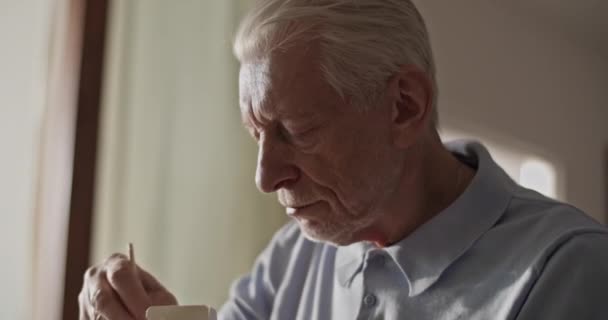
[234,0,438,124]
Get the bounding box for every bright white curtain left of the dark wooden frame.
[0,0,80,320]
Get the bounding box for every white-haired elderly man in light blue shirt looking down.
[80,0,608,320]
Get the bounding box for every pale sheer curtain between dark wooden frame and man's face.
[93,0,285,307]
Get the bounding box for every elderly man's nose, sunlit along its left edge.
[255,136,299,193]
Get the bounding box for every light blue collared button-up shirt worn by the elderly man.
[219,141,608,320]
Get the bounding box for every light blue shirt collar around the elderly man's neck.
[336,140,514,296]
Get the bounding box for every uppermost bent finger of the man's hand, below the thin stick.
[104,254,151,319]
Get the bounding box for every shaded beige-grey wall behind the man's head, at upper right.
[416,0,608,222]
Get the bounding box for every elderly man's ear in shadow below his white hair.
[388,65,434,148]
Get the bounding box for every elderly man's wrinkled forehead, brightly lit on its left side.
[239,50,338,118]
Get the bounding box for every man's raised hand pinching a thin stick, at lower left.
[78,253,177,320]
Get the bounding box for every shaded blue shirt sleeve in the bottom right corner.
[517,233,608,320]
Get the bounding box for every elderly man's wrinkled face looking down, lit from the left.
[240,50,402,245]
